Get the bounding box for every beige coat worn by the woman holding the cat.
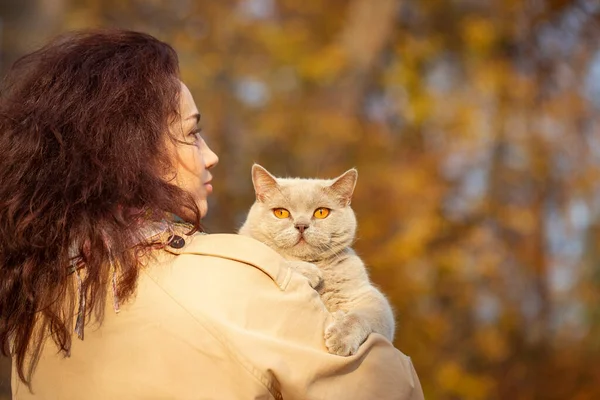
[13,234,423,400]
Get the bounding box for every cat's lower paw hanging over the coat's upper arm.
[325,310,369,356]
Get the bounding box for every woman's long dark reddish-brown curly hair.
[0,30,200,385]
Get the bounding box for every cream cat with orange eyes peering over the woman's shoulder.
[240,164,395,356]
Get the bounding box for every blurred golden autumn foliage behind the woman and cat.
[0,0,600,400]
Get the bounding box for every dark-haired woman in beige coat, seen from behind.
[0,30,422,399]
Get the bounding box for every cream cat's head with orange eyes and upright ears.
[240,164,358,260]
